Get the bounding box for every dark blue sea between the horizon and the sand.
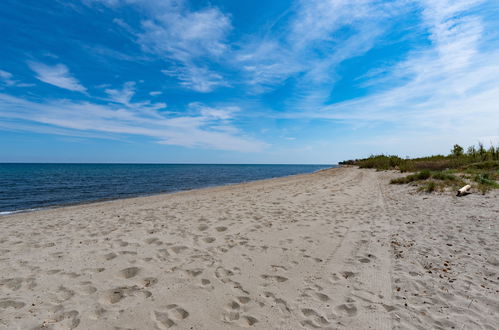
[0,163,332,214]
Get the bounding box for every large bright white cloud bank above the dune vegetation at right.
[289,0,499,150]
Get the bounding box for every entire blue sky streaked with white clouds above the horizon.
[0,0,499,164]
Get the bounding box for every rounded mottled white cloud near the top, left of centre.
[138,6,231,93]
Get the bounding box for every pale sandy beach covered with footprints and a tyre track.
[0,167,499,330]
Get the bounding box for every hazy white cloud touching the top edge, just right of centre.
[235,0,408,94]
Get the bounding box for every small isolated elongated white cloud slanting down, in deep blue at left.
[28,61,86,92]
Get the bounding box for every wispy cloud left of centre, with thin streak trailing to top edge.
[88,0,232,93]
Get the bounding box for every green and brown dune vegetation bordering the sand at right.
[340,143,499,193]
